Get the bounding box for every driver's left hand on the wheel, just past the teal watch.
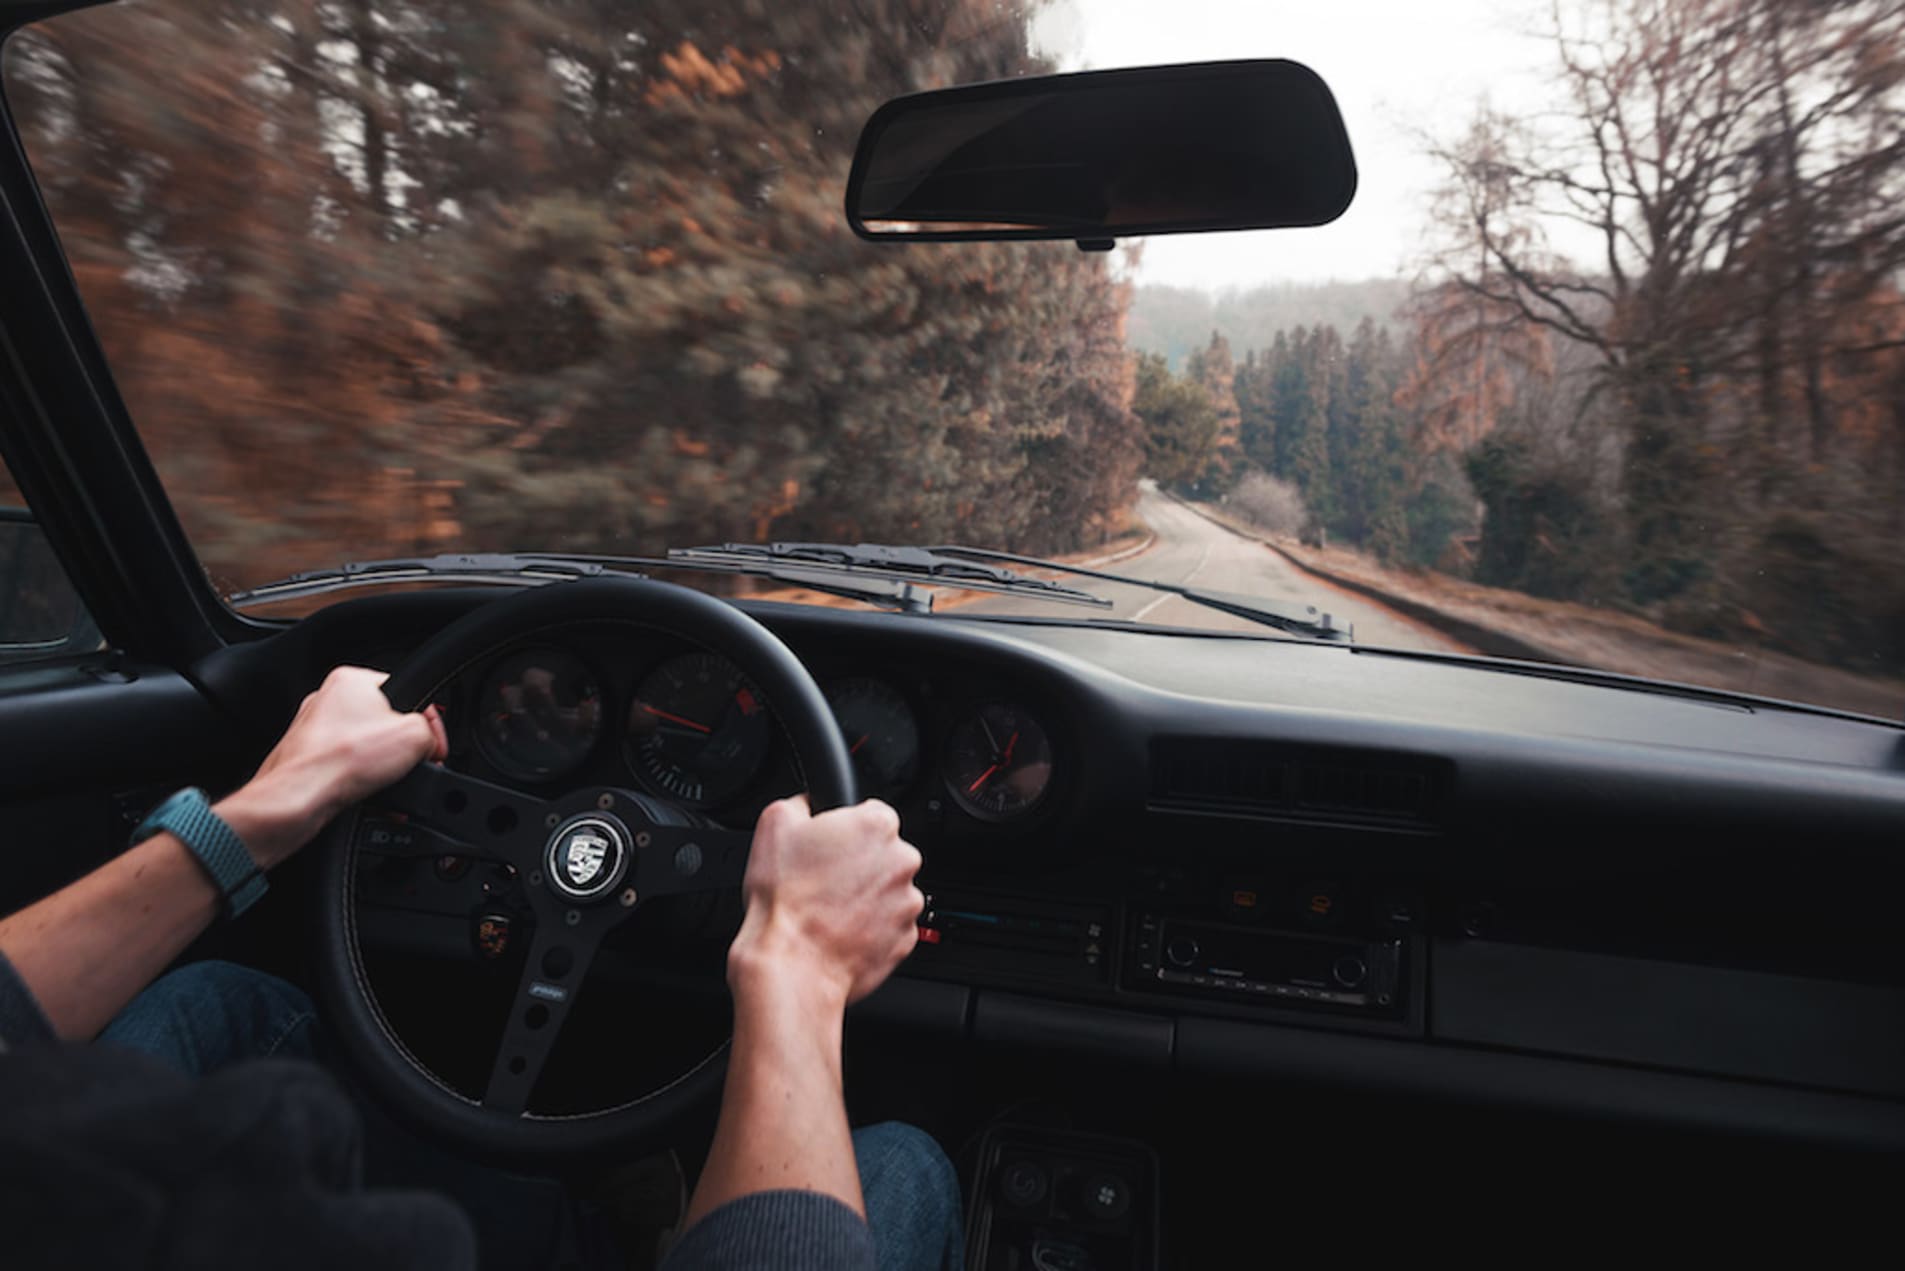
[219,667,450,869]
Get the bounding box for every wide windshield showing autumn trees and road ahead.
[6,0,1905,716]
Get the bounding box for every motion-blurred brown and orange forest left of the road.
[6,0,1143,589]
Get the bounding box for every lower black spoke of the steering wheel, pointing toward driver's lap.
[482,907,621,1117]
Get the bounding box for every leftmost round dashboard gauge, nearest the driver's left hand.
[476,648,602,781]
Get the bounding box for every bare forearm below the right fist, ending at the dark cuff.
[684,958,865,1227]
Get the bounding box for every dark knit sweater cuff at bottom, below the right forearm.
[661,1191,874,1271]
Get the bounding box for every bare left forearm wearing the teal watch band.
[0,791,295,1040]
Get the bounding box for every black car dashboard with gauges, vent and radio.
[204,593,1905,1149]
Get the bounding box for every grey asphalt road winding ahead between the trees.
[960,482,1465,652]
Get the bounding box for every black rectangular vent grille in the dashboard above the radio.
[1151,737,1446,827]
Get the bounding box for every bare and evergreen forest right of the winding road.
[1135,0,1905,673]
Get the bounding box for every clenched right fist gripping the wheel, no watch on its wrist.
[728,795,926,1004]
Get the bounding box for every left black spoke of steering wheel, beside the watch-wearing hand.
[366,764,551,871]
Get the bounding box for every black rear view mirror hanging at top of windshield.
[846,61,1356,248]
